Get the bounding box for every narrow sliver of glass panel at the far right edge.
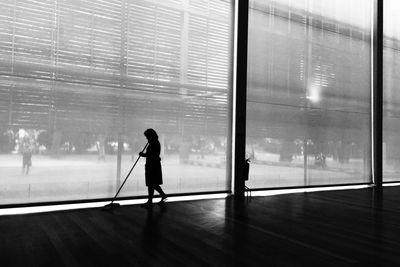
[383,0,400,182]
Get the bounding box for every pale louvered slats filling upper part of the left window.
[0,0,232,135]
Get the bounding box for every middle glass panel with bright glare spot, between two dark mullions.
[246,0,371,188]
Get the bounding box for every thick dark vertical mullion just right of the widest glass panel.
[232,0,249,198]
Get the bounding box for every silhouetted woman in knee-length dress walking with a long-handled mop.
[139,129,167,208]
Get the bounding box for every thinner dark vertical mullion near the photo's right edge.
[372,0,383,188]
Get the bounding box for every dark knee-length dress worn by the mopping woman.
[143,140,162,186]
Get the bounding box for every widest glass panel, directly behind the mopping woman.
[0,0,233,204]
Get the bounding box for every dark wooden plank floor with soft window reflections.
[0,187,400,267]
